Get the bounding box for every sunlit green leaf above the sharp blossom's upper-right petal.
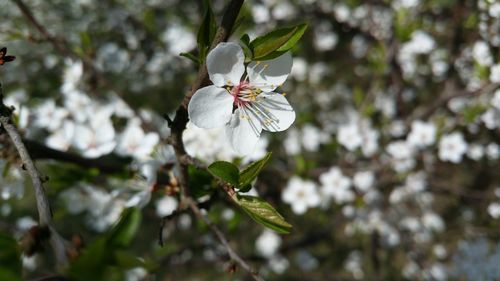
[250,23,307,60]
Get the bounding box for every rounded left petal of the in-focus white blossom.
[188,86,234,129]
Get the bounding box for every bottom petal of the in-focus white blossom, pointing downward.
[226,108,262,156]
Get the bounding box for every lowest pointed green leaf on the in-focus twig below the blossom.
[236,195,292,234]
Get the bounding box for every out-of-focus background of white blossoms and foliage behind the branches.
[0,0,500,280]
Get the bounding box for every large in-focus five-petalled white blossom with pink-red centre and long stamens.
[188,43,295,155]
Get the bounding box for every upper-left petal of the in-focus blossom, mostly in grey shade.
[207,43,245,87]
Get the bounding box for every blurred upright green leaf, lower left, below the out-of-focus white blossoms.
[109,208,141,247]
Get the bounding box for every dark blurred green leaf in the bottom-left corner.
[0,233,22,281]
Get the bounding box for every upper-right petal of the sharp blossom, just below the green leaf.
[247,52,293,92]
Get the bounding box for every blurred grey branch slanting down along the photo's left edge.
[0,84,68,267]
